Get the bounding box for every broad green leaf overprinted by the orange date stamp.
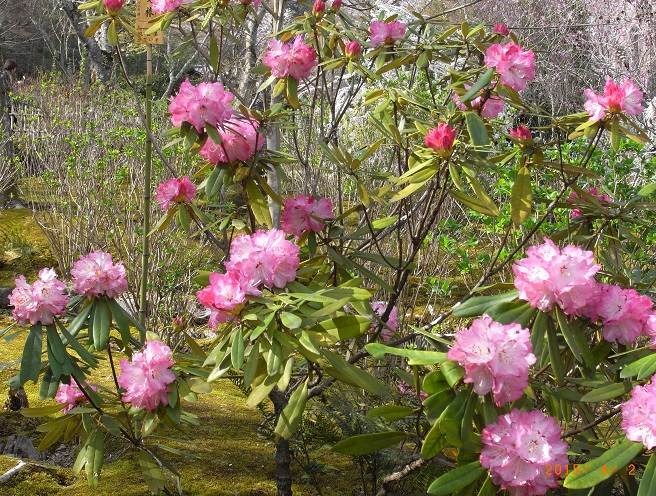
[563,441,644,489]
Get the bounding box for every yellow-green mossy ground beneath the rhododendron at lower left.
[0,315,358,496]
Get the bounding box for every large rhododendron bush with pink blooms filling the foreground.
[1,1,656,496]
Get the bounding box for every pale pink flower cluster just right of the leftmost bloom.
[71,250,128,299]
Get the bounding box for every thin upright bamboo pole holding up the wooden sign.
[139,45,153,343]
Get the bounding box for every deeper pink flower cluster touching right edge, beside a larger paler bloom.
[581,284,656,344]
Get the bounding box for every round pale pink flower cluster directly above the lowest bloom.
[446,315,535,406]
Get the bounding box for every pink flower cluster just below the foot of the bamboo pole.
[118,341,175,412]
